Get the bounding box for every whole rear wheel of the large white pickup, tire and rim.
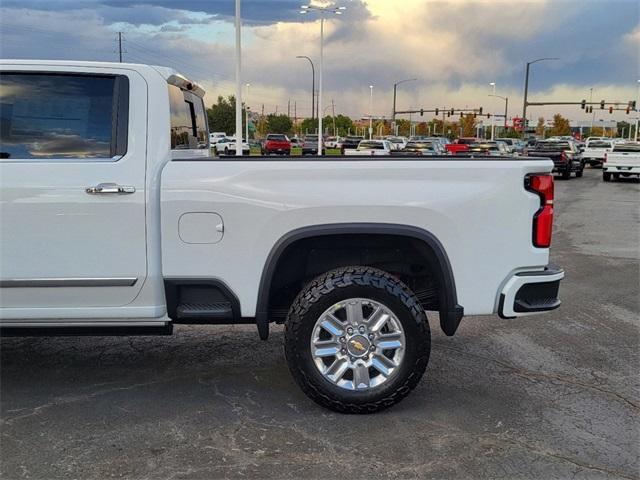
[285,267,431,413]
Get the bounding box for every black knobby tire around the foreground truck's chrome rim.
[285,267,431,413]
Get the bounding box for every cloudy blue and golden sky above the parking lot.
[0,0,640,124]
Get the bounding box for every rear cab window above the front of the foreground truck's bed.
[169,85,209,150]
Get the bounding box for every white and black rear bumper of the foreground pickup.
[498,265,564,318]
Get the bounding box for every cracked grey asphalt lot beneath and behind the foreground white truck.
[0,169,640,479]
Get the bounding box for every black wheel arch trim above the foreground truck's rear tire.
[256,223,464,339]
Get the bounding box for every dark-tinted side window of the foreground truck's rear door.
[0,72,129,160]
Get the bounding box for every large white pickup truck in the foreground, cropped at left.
[0,60,564,412]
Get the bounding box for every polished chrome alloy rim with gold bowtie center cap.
[311,298,405,391]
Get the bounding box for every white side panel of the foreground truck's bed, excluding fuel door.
[161,156,553,317]
